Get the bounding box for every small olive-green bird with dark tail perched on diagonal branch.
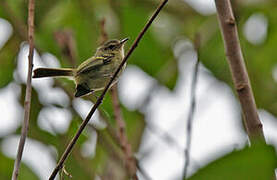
[33,38,128,97]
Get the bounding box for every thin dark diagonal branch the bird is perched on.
[49,0,168,180]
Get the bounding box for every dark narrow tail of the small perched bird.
[33,68,74,78]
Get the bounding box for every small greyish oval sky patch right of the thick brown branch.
[243,13,268,45]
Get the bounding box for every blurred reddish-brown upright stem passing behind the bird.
[100,19,138,179]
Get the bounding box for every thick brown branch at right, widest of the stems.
[212,0,265,143]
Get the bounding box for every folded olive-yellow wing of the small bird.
[77,56,113,75]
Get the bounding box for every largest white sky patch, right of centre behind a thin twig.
[140,59,247,180]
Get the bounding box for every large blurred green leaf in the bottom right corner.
[188,144,277,180]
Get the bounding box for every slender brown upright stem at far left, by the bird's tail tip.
[12,0,35,180]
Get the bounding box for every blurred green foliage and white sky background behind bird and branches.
[0,0,277,180]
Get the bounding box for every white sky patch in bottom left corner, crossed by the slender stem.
[1,136,56,179]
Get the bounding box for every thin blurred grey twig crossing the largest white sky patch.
[183,34,200,179]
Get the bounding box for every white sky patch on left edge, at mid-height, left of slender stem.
[0,83,23,137]
